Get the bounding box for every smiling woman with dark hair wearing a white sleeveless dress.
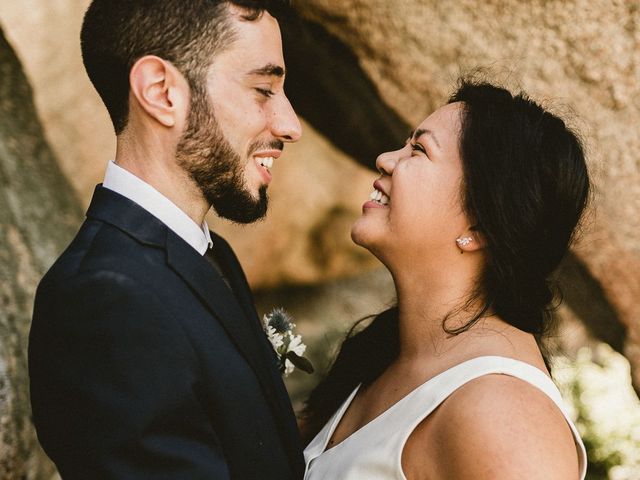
[302,80,589,480]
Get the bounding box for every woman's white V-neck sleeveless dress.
[304,356,587,480]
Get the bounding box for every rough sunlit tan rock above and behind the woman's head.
[296,0,640,390]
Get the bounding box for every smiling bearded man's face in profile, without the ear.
[177,7,300,223]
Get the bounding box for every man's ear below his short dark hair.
[129,55,189,127]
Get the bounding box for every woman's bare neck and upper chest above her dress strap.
[394,262,545,379]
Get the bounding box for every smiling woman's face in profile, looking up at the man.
[351,103,470,264]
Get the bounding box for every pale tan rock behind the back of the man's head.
[0,0,115,199]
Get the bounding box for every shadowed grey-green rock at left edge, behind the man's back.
[0,25,81,480]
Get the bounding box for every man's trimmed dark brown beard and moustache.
[176,87,282,223]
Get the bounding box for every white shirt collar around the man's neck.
[102,161,213,255]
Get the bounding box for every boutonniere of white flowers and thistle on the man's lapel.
[262,308,313,377]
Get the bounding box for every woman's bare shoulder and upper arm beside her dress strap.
[412,374,578,480]
